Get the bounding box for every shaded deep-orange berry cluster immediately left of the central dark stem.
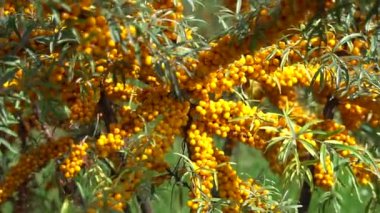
[121,90,190,171]
